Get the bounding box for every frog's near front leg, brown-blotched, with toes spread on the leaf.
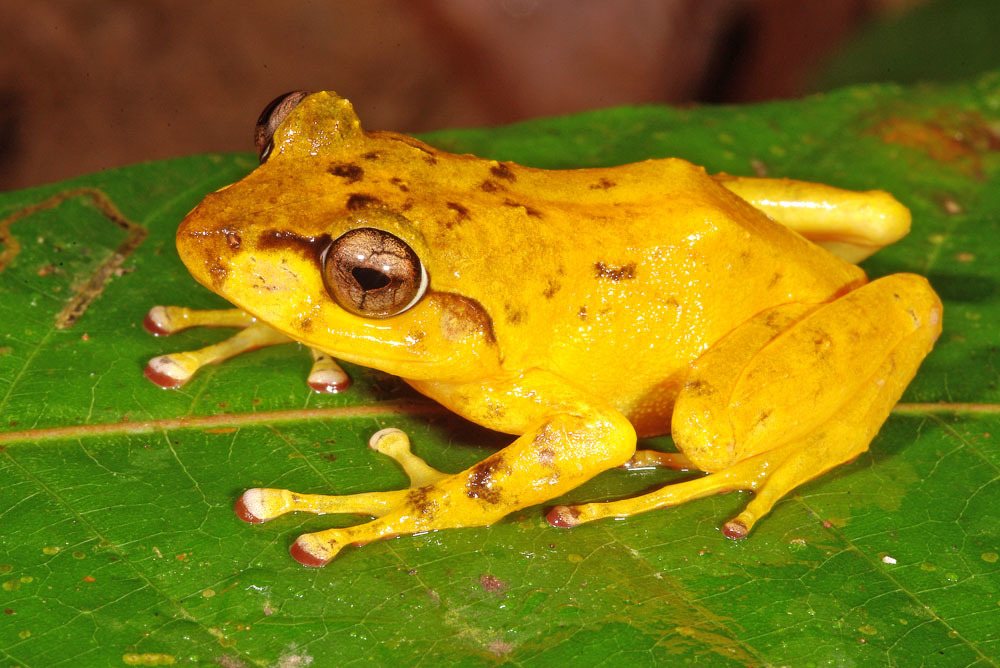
[236,374,635,566]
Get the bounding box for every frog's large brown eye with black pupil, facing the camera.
[323,227,427,318]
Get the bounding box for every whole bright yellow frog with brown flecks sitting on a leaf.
[146,92,942,567]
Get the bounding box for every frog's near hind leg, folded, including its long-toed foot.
[550,274,941,537]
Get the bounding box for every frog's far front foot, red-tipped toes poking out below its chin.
[142,306,351,393]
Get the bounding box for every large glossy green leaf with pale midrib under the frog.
[0,74,1000,668]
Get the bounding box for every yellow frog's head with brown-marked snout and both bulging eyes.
[177,93,497,381]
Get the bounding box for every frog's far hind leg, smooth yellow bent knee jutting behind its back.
[717,176,910,263]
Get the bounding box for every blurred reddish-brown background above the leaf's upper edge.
[0,0,1000,190]
